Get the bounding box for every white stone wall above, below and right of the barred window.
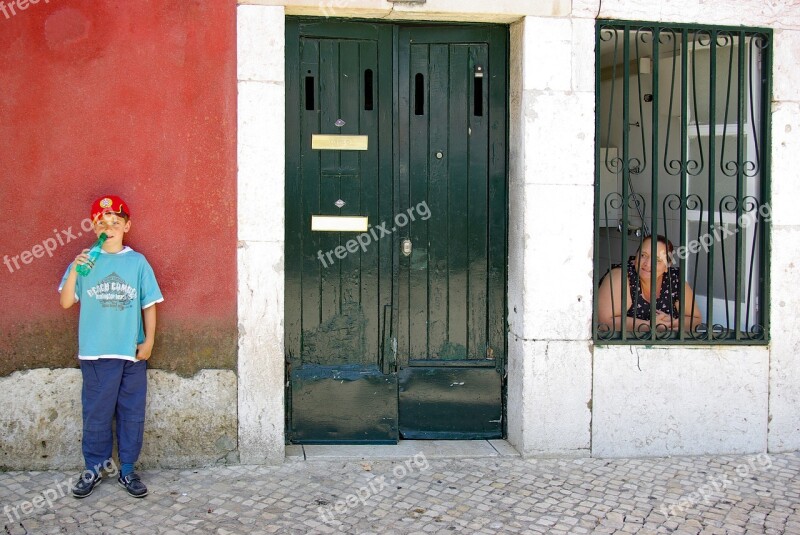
[574,0,800,456]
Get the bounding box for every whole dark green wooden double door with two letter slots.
[285,18,507,443]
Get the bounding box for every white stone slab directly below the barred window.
[592,345,769,457]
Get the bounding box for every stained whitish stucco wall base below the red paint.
[0,369,238,470]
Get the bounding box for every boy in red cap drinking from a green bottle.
[59,195,164,498]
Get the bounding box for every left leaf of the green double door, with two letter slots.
[286,21,397,443]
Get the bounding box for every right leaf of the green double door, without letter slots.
[398,27,507,438]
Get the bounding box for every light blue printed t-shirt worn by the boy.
[58,247,164,361]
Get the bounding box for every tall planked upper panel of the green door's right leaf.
[400,39,494,360]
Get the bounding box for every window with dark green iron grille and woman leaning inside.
[593,21,772,344]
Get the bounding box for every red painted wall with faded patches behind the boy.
[0,0,236,375]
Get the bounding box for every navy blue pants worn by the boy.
[81,359,147,472]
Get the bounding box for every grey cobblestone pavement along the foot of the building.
[0,452,800,535]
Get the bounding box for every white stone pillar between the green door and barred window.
[507,17,594,455]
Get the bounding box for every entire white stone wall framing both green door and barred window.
[233,0,800,462]
